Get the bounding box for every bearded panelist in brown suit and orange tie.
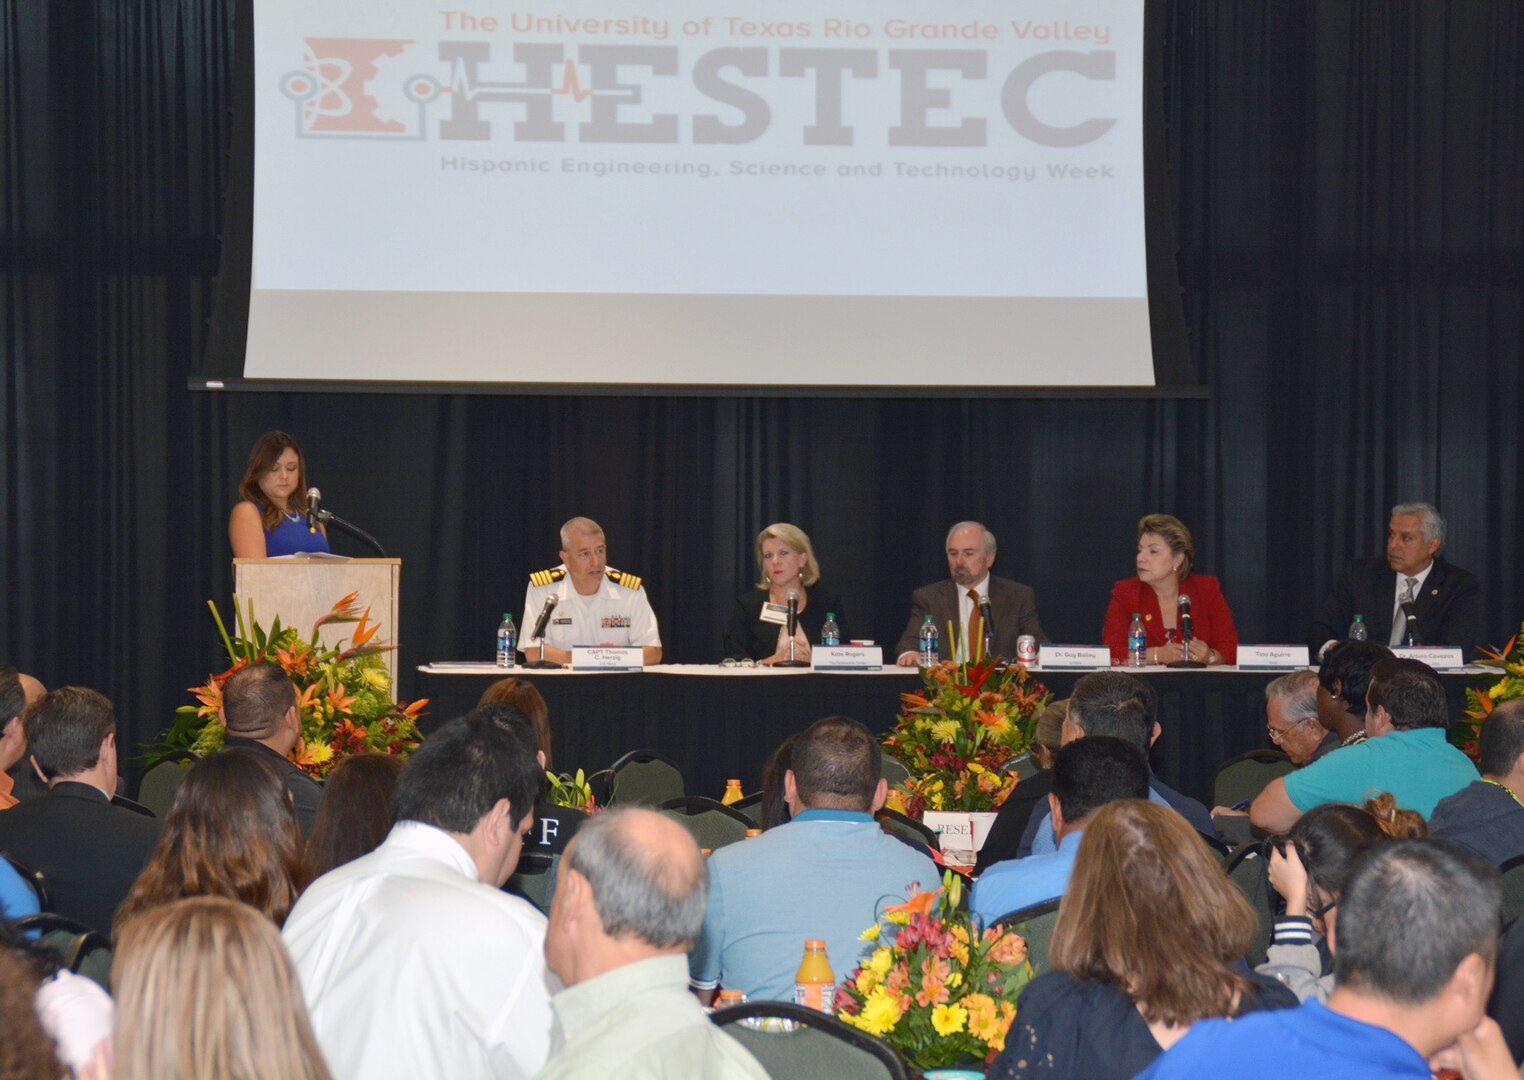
[895,521,1047,667]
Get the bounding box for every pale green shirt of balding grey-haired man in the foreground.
[536,954,768,1080]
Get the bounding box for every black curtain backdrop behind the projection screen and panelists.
[0,0,1524,766]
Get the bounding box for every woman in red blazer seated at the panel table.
[1100,513,1237,664]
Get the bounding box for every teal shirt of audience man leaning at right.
[1286,728,1477,820]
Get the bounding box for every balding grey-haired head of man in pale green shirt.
[565,807,709,952]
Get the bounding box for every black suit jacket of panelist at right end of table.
[1308,556,1481,658]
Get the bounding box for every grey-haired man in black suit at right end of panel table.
[1308,503,1481,657]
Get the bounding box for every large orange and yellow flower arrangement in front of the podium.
[145,593,428,778]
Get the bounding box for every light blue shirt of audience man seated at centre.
[689,810,942,1001]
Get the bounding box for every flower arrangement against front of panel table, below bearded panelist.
[884,648,1053,816]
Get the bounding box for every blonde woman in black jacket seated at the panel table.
[725,522,847,664]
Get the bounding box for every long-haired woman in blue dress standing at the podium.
[227,431,328,559]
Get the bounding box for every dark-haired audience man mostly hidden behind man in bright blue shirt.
[1018,672,1216,858]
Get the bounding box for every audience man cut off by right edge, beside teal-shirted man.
[1430,699,1524,867]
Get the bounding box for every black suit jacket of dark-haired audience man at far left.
[0,780,163,934]
